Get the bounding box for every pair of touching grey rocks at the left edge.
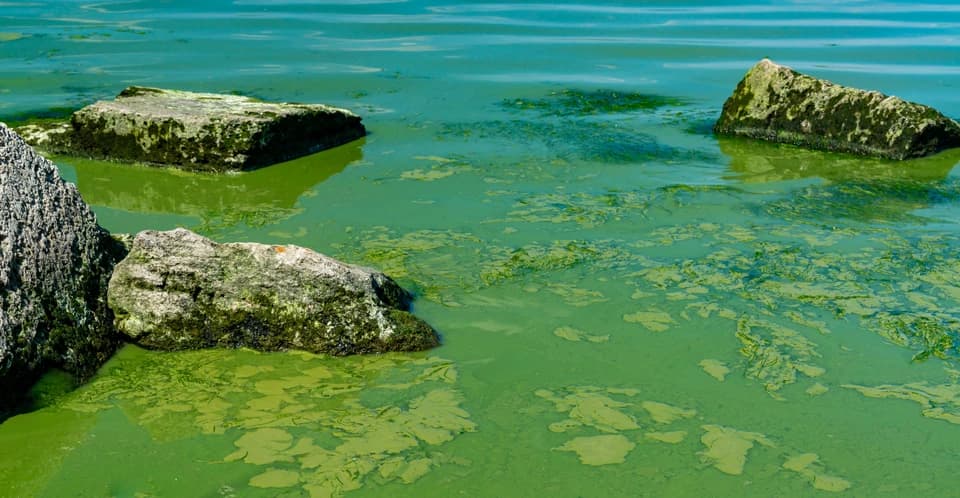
[0,123,439,412]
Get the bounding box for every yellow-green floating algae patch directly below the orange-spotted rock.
[11,347,477,497]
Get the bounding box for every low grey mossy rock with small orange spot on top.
[109,229,438,355]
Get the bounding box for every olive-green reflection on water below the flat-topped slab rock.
[63,139,365,232]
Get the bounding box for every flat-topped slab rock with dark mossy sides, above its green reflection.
[60,87,365,171]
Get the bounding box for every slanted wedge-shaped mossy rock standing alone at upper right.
[714,59,960,160]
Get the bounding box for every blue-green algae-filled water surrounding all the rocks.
[0,0,960,497]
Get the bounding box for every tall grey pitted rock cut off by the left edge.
[0,124,121,411]
